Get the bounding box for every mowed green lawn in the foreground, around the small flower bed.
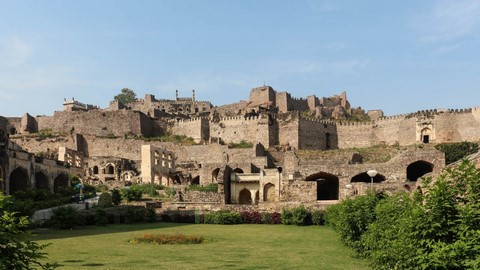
[33,223,369,270]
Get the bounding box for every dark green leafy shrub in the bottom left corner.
[0,192,56,269]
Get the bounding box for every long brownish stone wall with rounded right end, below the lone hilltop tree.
[36,110,154,137]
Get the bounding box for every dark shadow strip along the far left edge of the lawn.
[31,222,194,241]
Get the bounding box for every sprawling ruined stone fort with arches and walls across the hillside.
[0,86,480,210]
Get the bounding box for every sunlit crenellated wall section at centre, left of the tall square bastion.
[210,116,271,147]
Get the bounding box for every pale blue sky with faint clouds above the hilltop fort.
[0,0,480,116]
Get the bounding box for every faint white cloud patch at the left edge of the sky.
[0,36,33,67]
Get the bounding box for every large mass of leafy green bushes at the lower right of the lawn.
[327,160,480,269]
